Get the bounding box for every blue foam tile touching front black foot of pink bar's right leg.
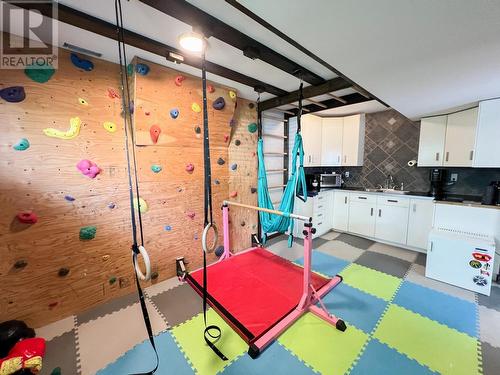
[323,283,387,333]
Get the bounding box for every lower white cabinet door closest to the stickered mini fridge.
[406,199,434,250]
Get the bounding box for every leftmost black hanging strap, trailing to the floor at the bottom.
[115,0,159,375]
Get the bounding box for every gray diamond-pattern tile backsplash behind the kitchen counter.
[305,109,500,196]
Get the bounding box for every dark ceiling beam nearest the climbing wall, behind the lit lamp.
[16,2,287,96]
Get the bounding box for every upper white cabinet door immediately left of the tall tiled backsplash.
[342,114,365,166]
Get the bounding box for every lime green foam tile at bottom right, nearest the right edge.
[373,305,480,375]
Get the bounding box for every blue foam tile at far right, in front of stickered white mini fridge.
[394,281,478,337]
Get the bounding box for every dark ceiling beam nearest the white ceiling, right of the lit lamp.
[140,0,325,85]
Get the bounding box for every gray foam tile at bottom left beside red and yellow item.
[40,329,78,375]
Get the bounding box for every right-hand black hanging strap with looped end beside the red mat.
[201,49,227,361]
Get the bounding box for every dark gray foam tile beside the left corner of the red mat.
[151,284,203,327]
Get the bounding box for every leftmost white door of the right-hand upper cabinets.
[418,116,447,167]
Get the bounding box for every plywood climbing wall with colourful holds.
[0,40,256,327]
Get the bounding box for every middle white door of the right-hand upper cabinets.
[443,108,477,167]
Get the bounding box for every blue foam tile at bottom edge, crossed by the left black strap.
[97,332,194,375]
